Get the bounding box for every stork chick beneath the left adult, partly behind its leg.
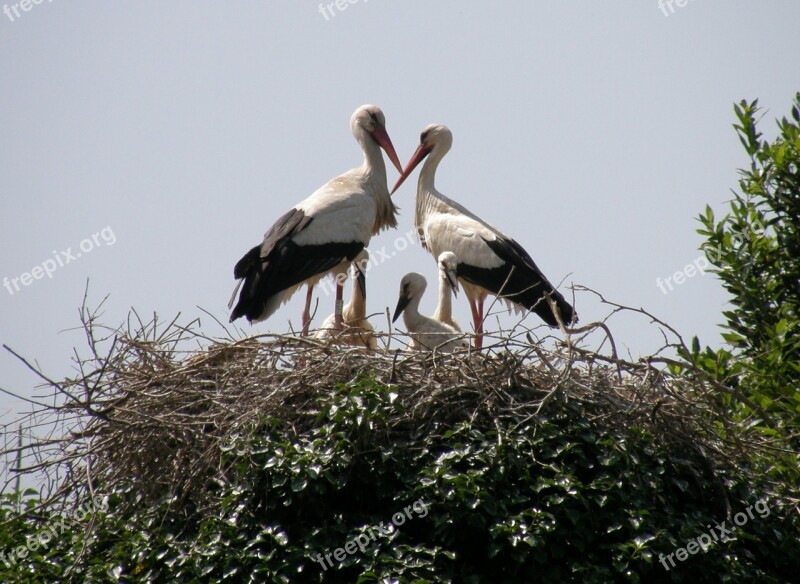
[314,249,378,350]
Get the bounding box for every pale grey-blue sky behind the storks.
[0,0,800,438]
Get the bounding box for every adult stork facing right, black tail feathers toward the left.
[228,105,402,331]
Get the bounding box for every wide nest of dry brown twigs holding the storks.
[0,288,770,520]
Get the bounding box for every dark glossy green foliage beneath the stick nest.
[0,379,800,583]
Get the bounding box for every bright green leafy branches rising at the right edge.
[686,93,800,428]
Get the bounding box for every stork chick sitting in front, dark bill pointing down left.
[392,272,467,353]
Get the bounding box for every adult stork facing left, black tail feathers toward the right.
[392,124,575,349]
